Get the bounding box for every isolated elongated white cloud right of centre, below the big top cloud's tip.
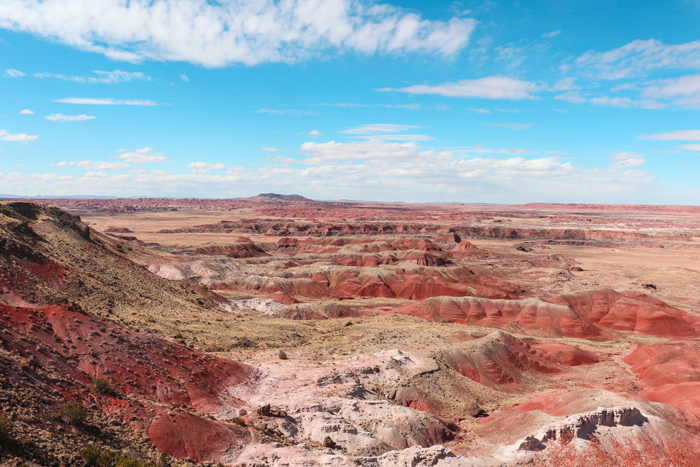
[378,76,537,100]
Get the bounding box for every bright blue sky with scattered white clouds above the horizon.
[0,0,700,204]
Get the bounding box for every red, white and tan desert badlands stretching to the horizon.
[0,194,700,467]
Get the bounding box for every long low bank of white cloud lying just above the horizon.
[0,141,669,203]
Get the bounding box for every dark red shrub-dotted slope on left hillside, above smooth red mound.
[0,304,254,414]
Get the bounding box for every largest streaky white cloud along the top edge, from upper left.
[0,0,476,67]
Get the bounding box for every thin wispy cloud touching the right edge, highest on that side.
[575,39,700,80]
